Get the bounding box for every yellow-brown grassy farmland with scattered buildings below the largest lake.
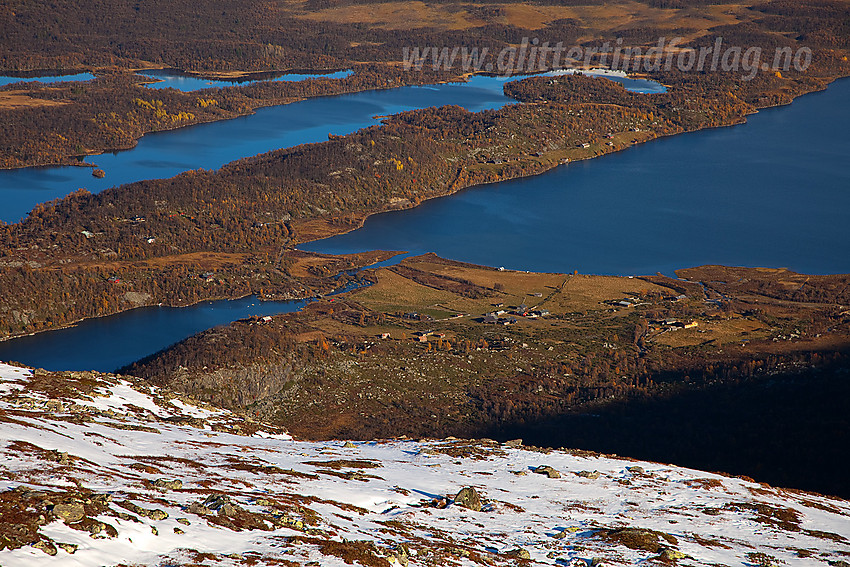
[276,254,848,358]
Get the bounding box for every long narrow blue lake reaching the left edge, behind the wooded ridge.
[0,77,528,222]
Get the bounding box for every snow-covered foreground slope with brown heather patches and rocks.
[0,364,850,567]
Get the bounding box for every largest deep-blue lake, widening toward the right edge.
[300,79,850,275]
